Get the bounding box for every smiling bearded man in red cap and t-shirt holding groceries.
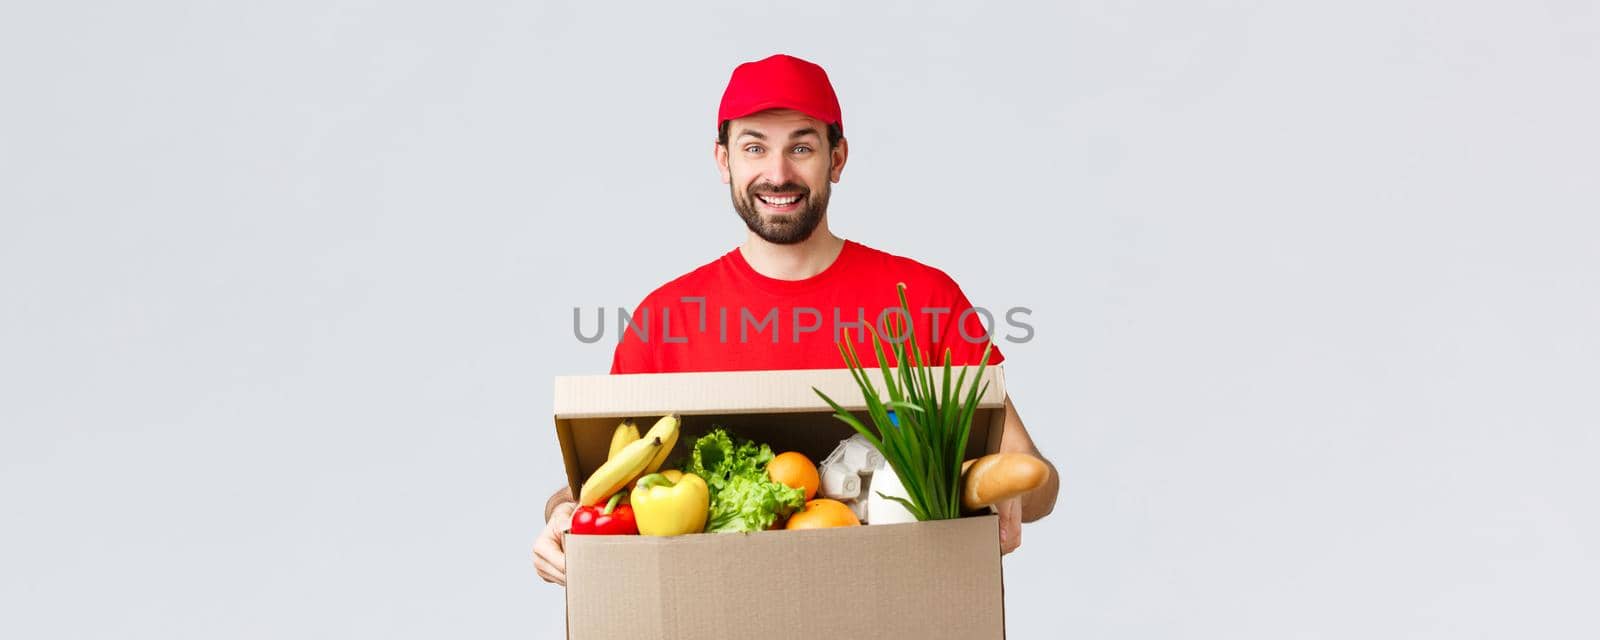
[533,54,1058,584]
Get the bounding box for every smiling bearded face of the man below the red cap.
[717,109,845,245]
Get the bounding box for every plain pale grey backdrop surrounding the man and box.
[0,0,1600,638]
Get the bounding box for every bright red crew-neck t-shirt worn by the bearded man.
[611,240,1005,373]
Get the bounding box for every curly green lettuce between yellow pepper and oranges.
[688,427,805,533]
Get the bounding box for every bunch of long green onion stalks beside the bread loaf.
[811,283,994,520]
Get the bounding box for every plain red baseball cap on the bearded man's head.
[717,53,845,131]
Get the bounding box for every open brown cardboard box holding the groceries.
[555,366,1005,640]
